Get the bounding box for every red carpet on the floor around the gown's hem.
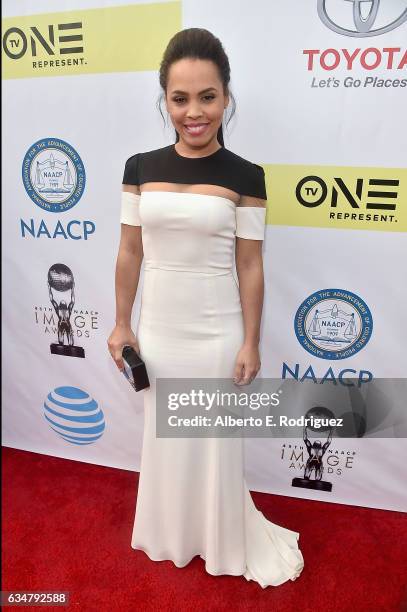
[2,448,407,612]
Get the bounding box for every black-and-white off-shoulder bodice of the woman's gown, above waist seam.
[120,145,266,274]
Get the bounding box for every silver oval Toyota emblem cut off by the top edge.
[317,0,407,38]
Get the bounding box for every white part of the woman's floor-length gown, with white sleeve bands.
[121,191,304,588]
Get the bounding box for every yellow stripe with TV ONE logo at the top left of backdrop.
[2,2,182,79]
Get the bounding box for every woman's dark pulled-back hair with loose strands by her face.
[158,28,236,146]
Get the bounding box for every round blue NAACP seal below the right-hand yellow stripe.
[294,289,373,360]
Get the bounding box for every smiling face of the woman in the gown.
[166,58,229,148]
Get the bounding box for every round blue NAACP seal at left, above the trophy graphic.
[22,138,86,213]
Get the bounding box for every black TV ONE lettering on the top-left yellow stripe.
[3,21,83,60]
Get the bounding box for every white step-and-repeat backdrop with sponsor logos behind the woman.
[2,0,407,511]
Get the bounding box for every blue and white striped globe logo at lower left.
[44,387,105,445]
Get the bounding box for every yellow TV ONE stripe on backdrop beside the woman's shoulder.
[263,164,407,232]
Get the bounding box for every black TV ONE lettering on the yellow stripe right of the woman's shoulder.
[295,175,400,221]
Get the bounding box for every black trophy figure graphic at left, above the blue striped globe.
[48,263,85,357]
